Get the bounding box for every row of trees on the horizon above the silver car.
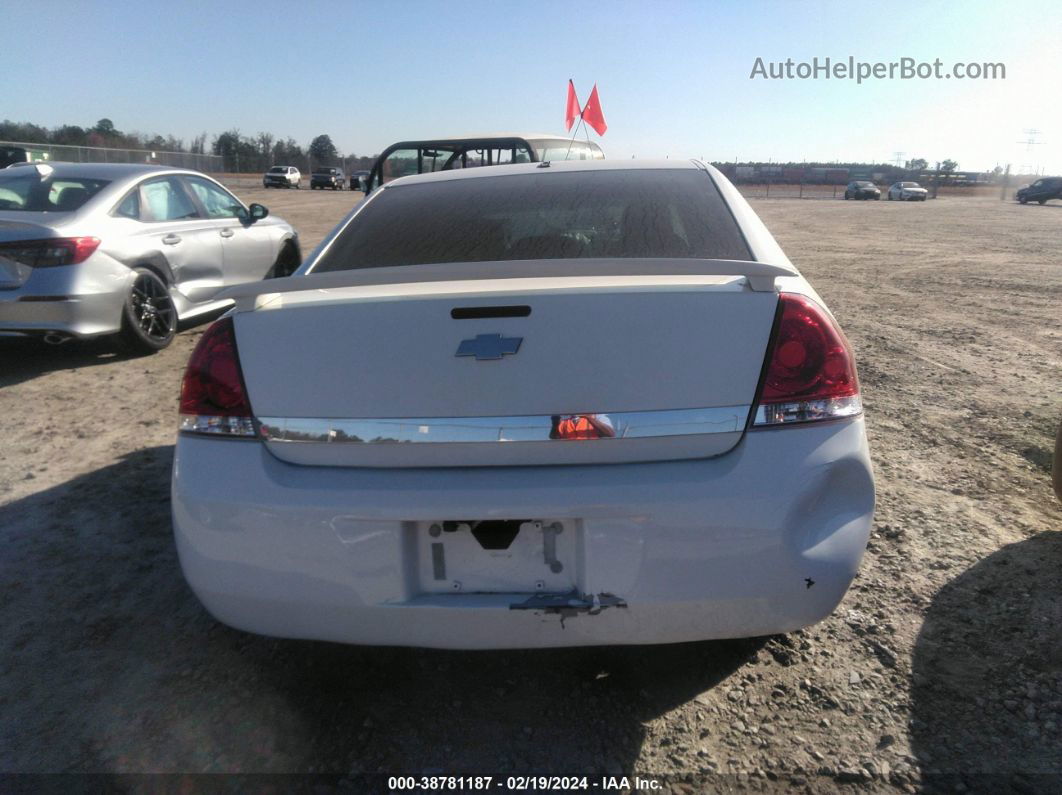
[0,118,376,173]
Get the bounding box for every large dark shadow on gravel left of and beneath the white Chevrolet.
[0,450,765,779]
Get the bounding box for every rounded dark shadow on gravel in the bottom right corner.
[911,532,1062,792]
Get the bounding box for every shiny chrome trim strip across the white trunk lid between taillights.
[258,405,751,445]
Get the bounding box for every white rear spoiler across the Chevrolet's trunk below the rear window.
[218,258,798,309]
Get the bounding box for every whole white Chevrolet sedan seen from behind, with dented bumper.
[173,160,874,649]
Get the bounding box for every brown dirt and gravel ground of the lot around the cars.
[0,188,1062,792]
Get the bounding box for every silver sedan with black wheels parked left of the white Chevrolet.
[0,163,302,352]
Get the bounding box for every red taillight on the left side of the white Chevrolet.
[179,317,255,436]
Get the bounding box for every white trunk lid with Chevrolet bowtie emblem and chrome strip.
[235,269,777,467]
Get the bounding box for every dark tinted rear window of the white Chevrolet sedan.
[312,169,752,273]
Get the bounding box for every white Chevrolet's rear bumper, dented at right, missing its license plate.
[173,418,874,649]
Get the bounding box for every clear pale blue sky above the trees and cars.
[8,0,1062,173]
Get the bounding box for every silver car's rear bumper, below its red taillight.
[0,254,133,336]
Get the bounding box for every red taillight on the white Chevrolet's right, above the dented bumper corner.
[753,293,862,426]
